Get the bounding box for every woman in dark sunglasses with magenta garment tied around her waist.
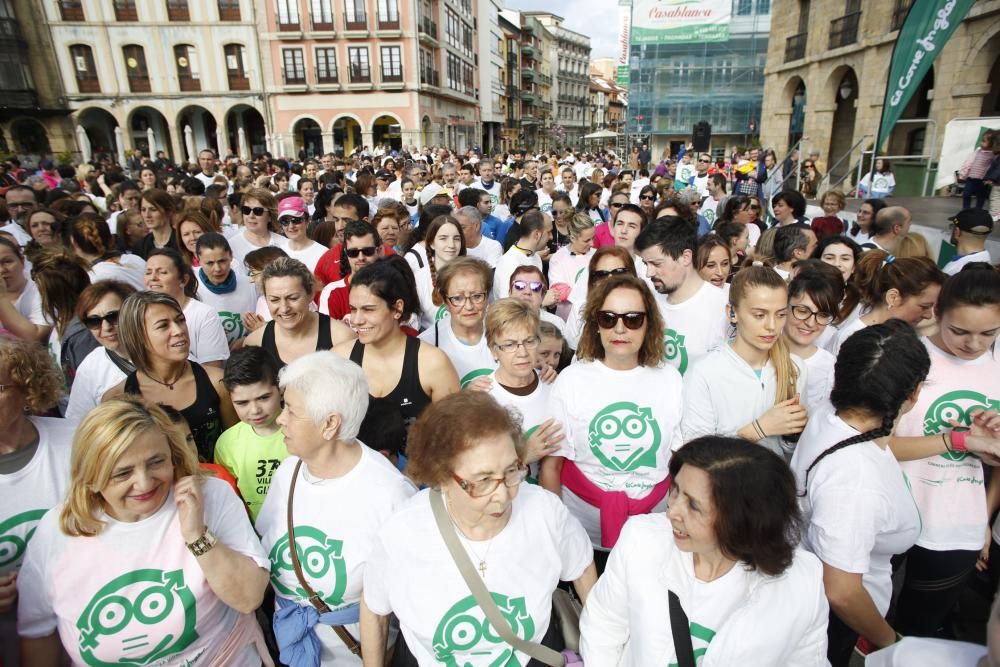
[541,275,683,563]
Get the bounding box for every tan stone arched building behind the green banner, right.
[761,0,1000,184]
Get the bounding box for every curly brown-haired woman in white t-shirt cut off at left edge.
[0,336,76,665]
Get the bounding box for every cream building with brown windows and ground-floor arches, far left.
[41,0,267,166]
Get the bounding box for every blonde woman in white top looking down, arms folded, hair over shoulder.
[684,262,808,459]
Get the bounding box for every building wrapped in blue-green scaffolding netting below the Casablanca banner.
[627,0,771,158]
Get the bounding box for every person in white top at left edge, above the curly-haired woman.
[0,236,52,344]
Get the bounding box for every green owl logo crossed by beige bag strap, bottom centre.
[434,592,535,667]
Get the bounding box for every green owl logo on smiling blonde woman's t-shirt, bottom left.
[76,569,198,667]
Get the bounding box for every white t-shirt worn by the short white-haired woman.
[256,445,416,665]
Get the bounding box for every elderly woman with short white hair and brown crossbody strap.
[256,352,416,667]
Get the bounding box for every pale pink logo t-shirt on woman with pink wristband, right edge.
[896,338,1000,551]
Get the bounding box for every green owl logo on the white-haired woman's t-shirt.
[268,526,347,608]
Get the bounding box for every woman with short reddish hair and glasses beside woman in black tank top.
[420,257,497,389]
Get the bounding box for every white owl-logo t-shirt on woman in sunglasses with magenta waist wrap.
[549,361,684,544]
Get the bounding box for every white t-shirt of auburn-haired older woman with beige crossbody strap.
[364,484,594,667]
